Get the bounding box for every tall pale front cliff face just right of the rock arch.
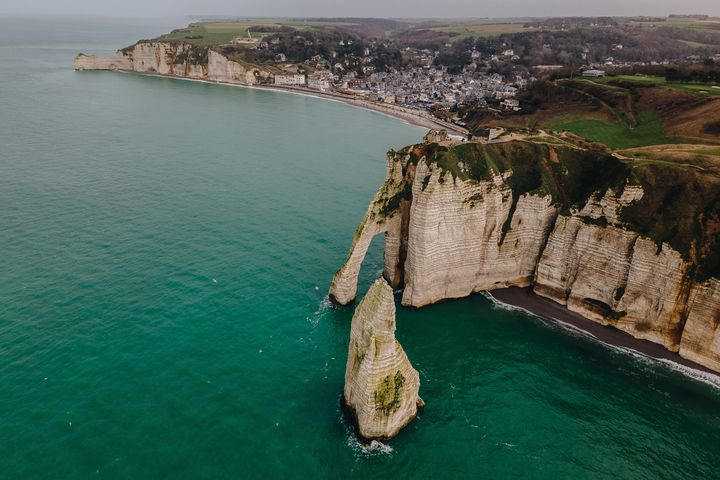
[403,161,557,307]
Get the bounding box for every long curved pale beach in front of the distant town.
[112,70,470,137]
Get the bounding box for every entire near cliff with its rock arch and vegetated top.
[330,133,720,371]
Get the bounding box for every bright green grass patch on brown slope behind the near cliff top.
[550,112,679,148]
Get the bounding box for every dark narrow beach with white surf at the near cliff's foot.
[487,287,720,388]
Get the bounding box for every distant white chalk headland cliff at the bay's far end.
[75,41,271,85]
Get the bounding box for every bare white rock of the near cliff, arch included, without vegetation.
[331,137,720,371]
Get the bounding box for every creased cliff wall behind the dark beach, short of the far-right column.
[534,216,688,351]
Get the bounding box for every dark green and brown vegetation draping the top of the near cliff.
[399,141,720,280]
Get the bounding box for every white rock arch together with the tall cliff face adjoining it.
[330,148,557,307]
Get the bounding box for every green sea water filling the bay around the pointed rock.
[0,17,720,480]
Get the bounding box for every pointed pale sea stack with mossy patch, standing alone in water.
[343,278,423,440]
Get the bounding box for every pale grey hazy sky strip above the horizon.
[0,0,720,18]
